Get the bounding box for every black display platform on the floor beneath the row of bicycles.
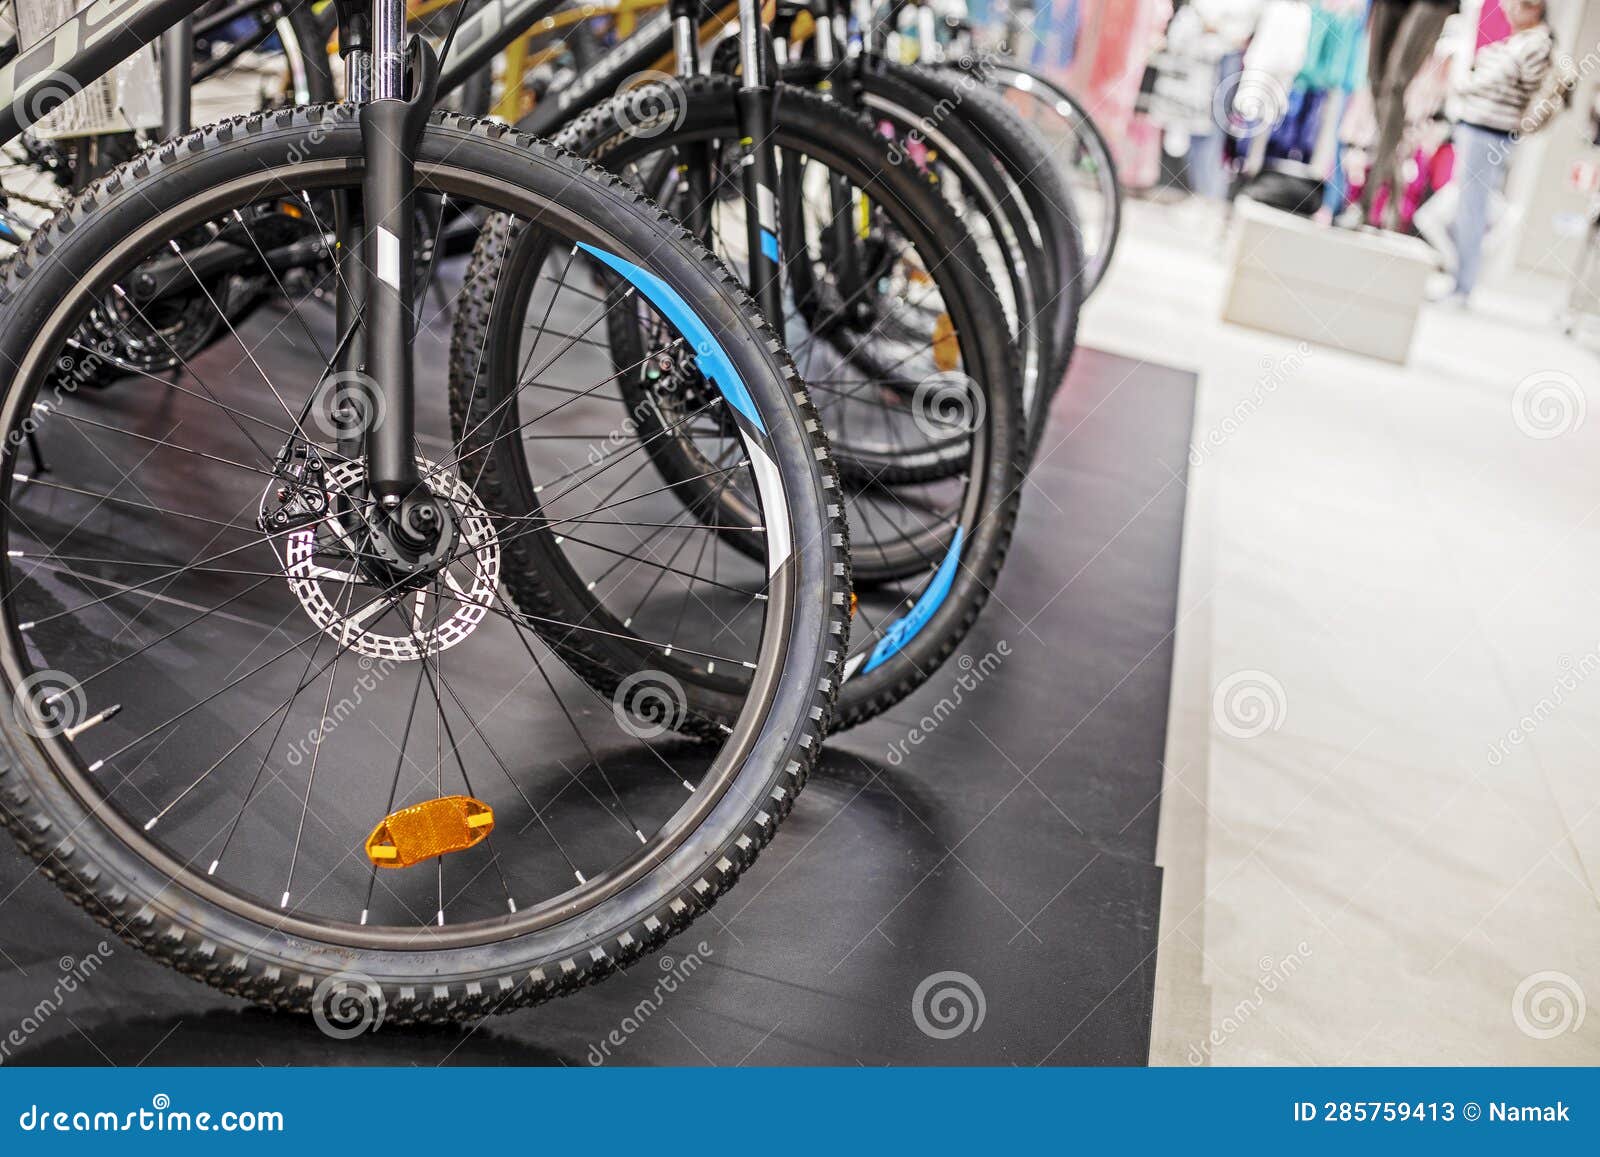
[0,350,1194,1066]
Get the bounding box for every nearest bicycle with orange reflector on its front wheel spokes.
[0,0,850,1021]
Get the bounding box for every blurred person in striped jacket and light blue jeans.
[1450,0,1555,304]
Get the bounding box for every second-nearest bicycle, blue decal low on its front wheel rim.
[451,0,1026,727]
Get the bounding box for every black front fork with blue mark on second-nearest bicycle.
[734,0,784,330]
